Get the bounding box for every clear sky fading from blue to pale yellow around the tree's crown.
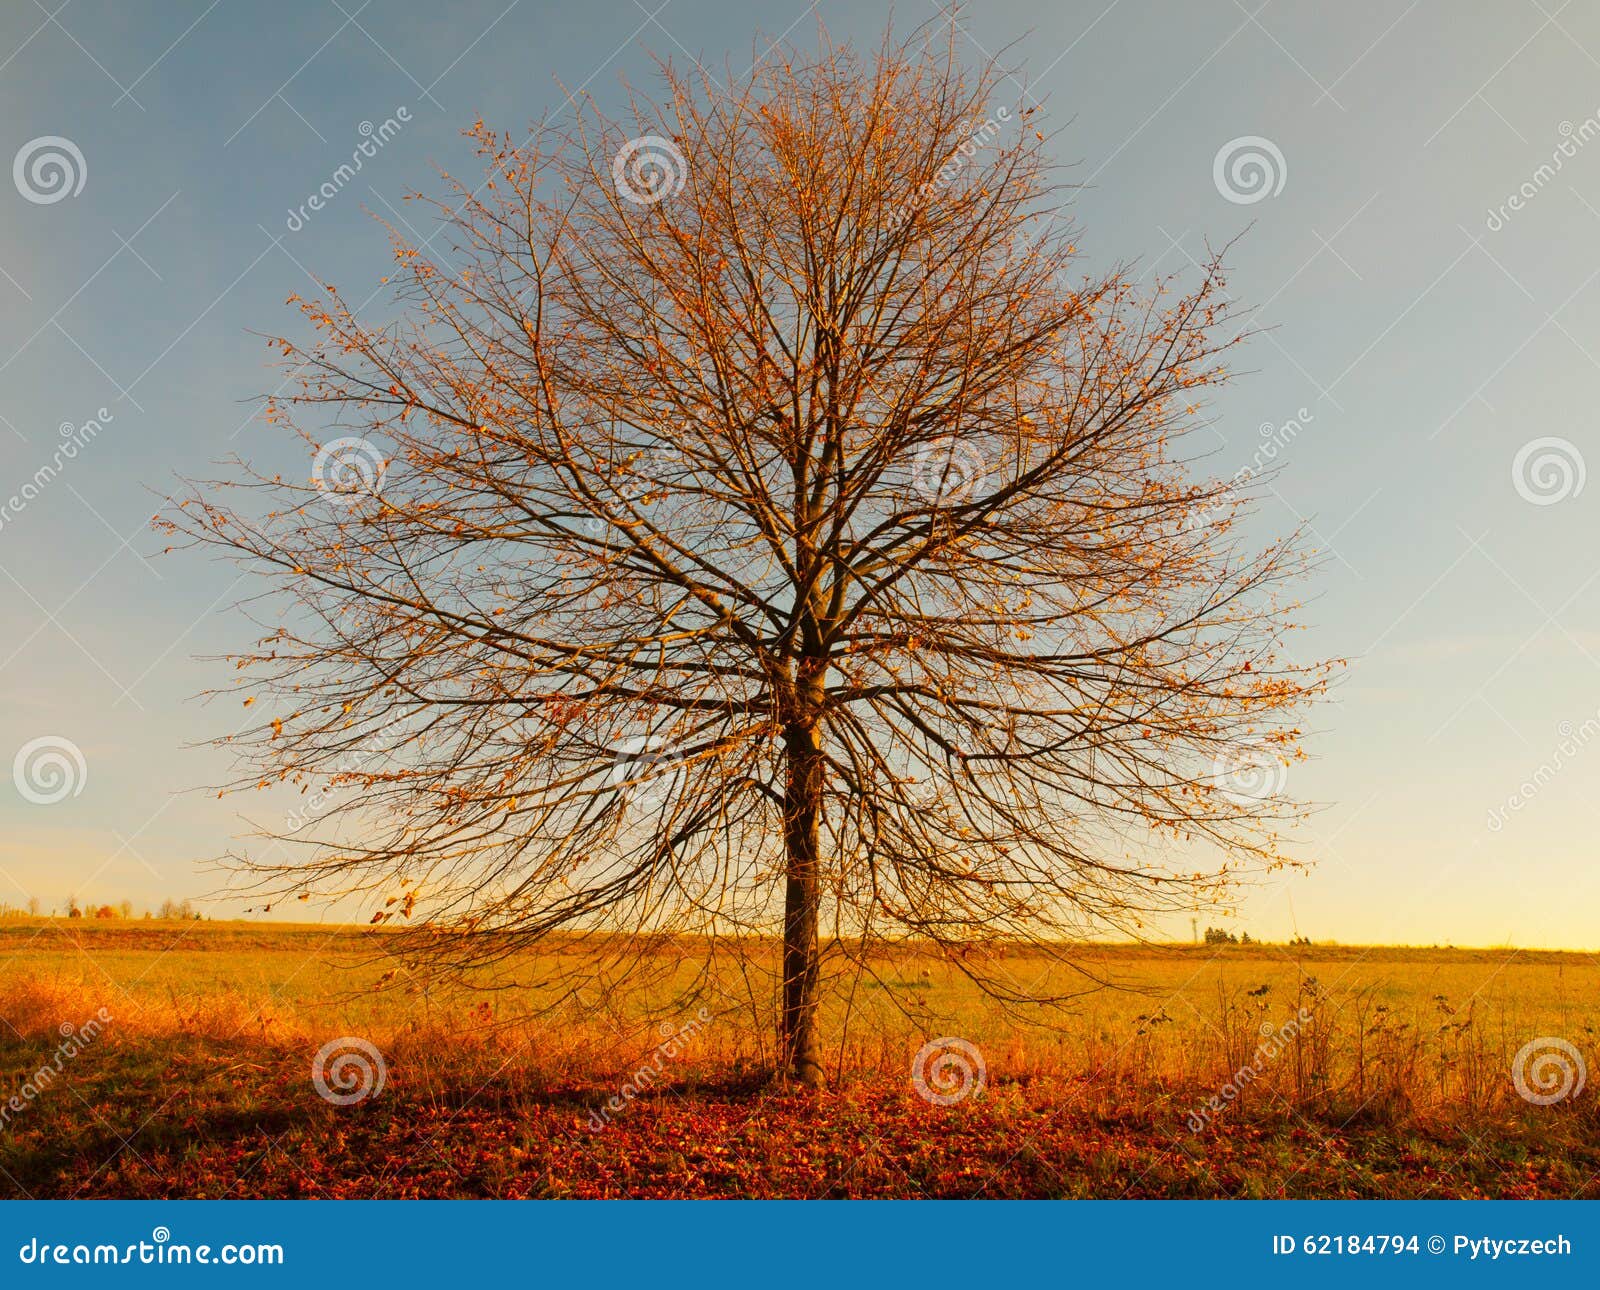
[0,0,1600,947]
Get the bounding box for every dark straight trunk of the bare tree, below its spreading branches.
[781,723,822,1087]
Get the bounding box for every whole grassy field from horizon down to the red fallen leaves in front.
[0,919,1600,1197]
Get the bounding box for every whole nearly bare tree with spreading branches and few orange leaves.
[163,22,1323,1084]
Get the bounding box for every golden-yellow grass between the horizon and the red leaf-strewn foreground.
[0,920,1600,1119]
